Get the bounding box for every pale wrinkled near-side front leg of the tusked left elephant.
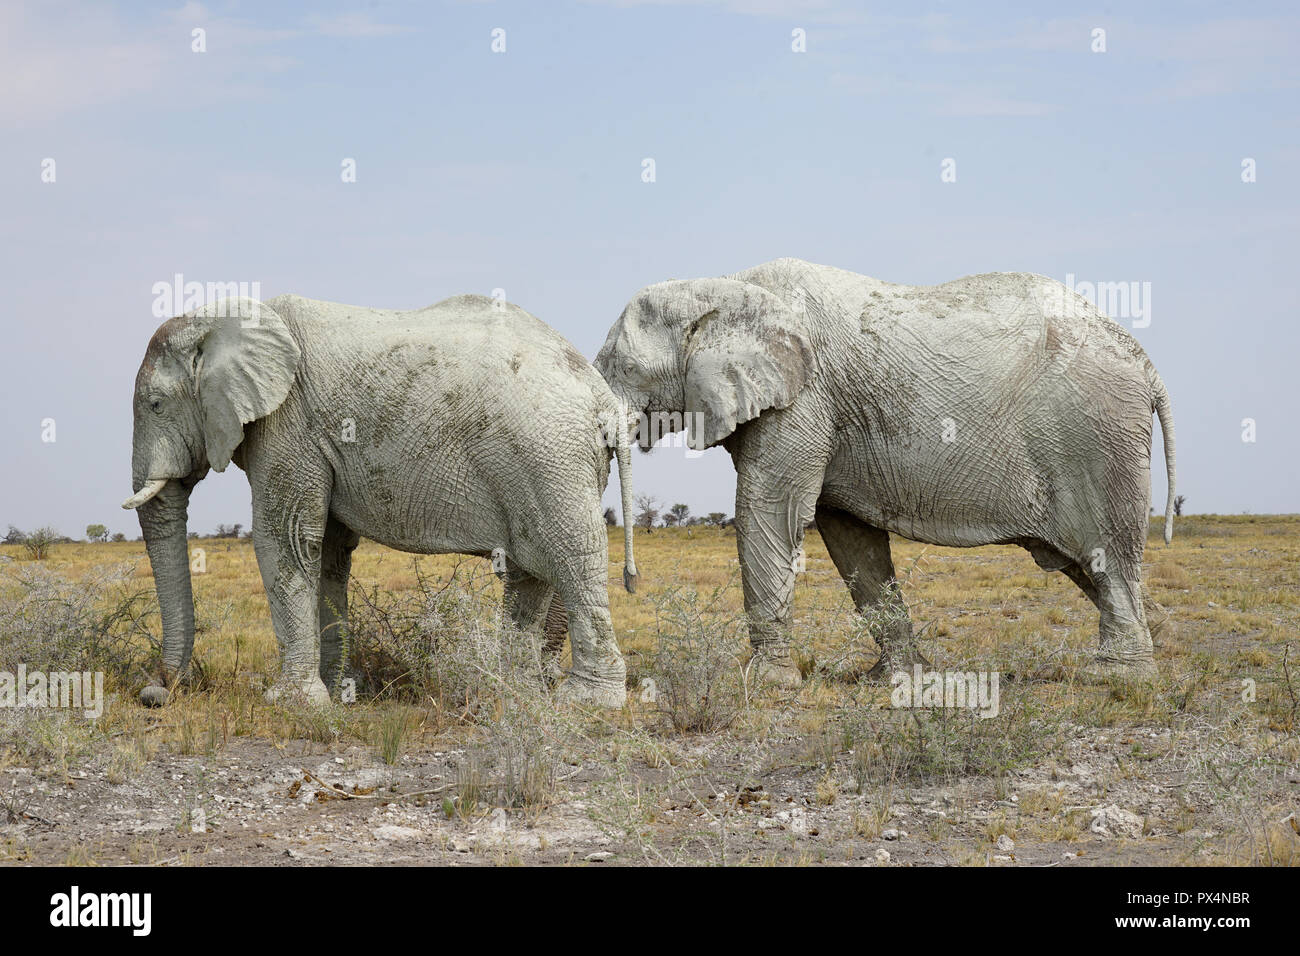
[254,493,329,704]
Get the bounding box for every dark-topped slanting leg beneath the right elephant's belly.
[816,502,924,678]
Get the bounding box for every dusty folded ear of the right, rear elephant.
[685,280,813,449]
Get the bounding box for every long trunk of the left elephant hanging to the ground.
[139,479,194,696]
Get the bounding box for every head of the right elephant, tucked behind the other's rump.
[595,278,813,449]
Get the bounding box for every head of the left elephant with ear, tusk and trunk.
[122,299,300,697]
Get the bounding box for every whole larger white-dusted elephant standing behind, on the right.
[595,259,1174,683]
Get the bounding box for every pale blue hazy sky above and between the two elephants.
[0,0,1300,537]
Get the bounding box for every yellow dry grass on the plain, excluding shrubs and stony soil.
[0,516,1300,862]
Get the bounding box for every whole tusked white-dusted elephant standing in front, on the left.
[124,295,636,706]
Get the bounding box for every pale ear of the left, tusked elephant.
[178,298,302,471]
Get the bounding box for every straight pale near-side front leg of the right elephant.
[736,470,820,687]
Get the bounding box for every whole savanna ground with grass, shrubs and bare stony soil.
[0,516,1300,866]
